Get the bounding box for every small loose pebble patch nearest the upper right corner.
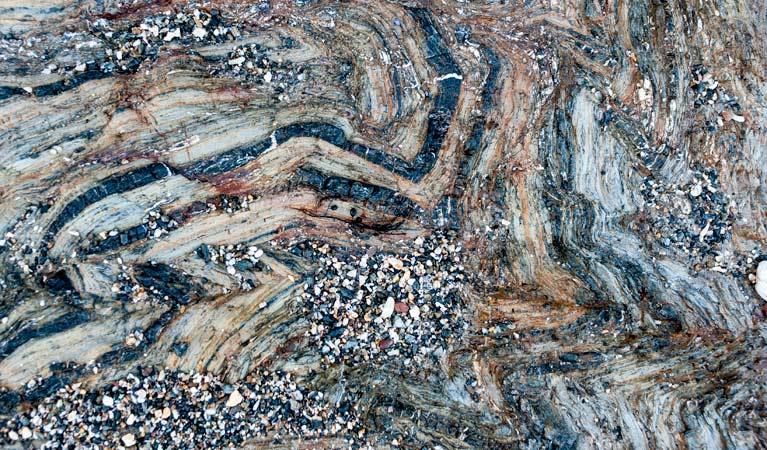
[690,65,746,133]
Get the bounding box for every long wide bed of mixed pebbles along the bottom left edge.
[0,367,365,449]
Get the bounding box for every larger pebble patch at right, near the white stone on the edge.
[640,167,737,267]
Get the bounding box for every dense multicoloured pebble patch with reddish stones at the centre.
[301,234,468,365]
